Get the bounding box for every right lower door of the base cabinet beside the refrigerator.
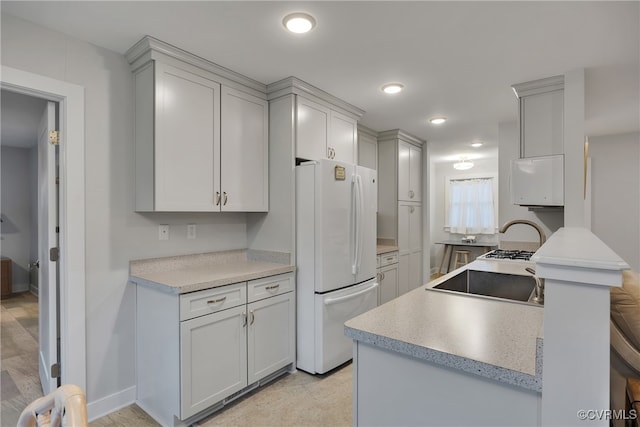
[247,292,296,384]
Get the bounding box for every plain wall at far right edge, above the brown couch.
[589,132,640,271]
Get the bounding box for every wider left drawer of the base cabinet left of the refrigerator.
[180,282,247,321]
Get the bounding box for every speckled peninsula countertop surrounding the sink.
[345,261,543,391]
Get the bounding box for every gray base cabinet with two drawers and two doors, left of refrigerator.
[136,273,295,426]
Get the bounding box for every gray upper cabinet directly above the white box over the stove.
[513,76,564,157]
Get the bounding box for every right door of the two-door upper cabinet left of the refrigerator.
[220,86,269,212]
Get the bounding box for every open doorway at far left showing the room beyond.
[0,89,60,397]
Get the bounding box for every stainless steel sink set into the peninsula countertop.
[427,270,536,303]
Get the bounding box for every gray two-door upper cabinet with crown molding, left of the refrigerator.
[127,37,269,212]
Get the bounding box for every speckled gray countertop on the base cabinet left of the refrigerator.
[130,249,295,294]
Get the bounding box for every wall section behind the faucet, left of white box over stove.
[498,122,564,245]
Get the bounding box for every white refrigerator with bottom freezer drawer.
[296,159,378,374]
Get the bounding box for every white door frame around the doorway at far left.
[0,66,87,392]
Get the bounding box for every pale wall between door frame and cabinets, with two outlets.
[1,15,247,409]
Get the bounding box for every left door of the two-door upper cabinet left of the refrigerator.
[154,62,220,212]
